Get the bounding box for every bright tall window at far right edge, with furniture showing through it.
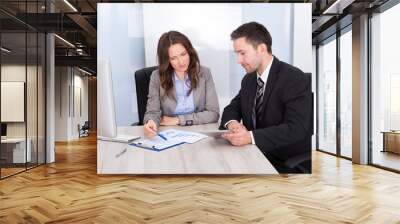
[371,4,400,170]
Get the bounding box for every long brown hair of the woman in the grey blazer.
[157,31,200,95]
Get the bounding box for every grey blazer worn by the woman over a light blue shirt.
[143,66,219,126]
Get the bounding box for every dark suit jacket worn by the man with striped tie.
[220,57,313,171]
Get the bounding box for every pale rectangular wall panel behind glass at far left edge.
[1,82,25,122]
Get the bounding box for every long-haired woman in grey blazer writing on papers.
[143,31,219,137]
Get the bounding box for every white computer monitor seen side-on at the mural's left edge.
[97,59,140,142]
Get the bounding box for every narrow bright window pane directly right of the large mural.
[318,39,336,153]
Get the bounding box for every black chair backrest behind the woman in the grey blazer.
[135,66,158,125]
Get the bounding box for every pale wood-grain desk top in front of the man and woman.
[97,124,277,174]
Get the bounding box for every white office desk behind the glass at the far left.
[1,138,32,163]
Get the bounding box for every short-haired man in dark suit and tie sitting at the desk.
[220,22,313,173]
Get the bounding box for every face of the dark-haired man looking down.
[233,37,262,73]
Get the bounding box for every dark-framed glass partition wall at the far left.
[0,0,46,178]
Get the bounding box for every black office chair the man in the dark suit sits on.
[285,73,314,173]
